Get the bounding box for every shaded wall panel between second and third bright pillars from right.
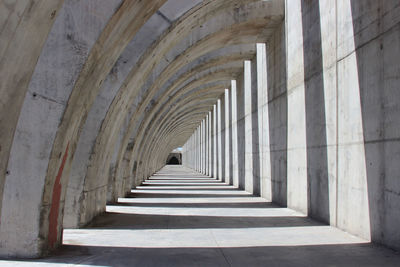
[266,23,288,206]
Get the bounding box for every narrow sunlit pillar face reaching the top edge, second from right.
[286,1,308,214]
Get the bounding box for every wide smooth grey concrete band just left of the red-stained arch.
[0,1,120,255]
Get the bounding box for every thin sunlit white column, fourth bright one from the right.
[244,60,254,193]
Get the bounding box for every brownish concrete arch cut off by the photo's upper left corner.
[0,0,63,228]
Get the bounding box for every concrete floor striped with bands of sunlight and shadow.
[0,166,400,266]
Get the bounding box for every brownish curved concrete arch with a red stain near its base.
[39,0,166,254]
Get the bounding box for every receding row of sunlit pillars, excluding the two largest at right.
[182,43,271,199]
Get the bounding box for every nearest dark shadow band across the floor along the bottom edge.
[5,244,400,267]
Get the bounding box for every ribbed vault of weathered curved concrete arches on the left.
[0,0,284,255]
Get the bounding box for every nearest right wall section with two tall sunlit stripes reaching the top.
[286,1,400,251]
